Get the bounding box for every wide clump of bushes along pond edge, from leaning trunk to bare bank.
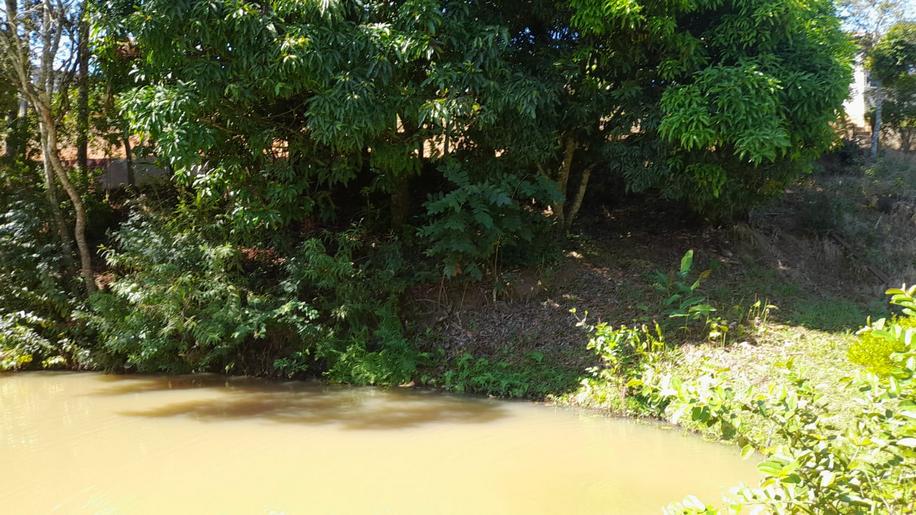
[89,209,414,383]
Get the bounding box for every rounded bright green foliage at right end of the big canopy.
[571,0,852,217]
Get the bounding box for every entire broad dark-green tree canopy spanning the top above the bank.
[118,0,850,240]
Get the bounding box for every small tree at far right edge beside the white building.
[868,22,916,151]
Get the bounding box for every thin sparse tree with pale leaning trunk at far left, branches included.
[0,0,95,293]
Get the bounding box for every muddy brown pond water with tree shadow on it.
[0,373,755,515]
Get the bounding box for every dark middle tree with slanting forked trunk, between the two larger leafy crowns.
[476,1,658,231]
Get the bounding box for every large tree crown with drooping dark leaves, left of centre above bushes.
[124,0,536,235]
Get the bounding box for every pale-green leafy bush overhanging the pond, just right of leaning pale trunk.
[89,214,317,374]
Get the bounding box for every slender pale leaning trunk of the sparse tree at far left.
[35,108,95,293]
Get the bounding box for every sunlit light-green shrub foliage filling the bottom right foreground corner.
[656,287,916,513]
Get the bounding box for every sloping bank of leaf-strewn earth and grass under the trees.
[415,149,916,409]
